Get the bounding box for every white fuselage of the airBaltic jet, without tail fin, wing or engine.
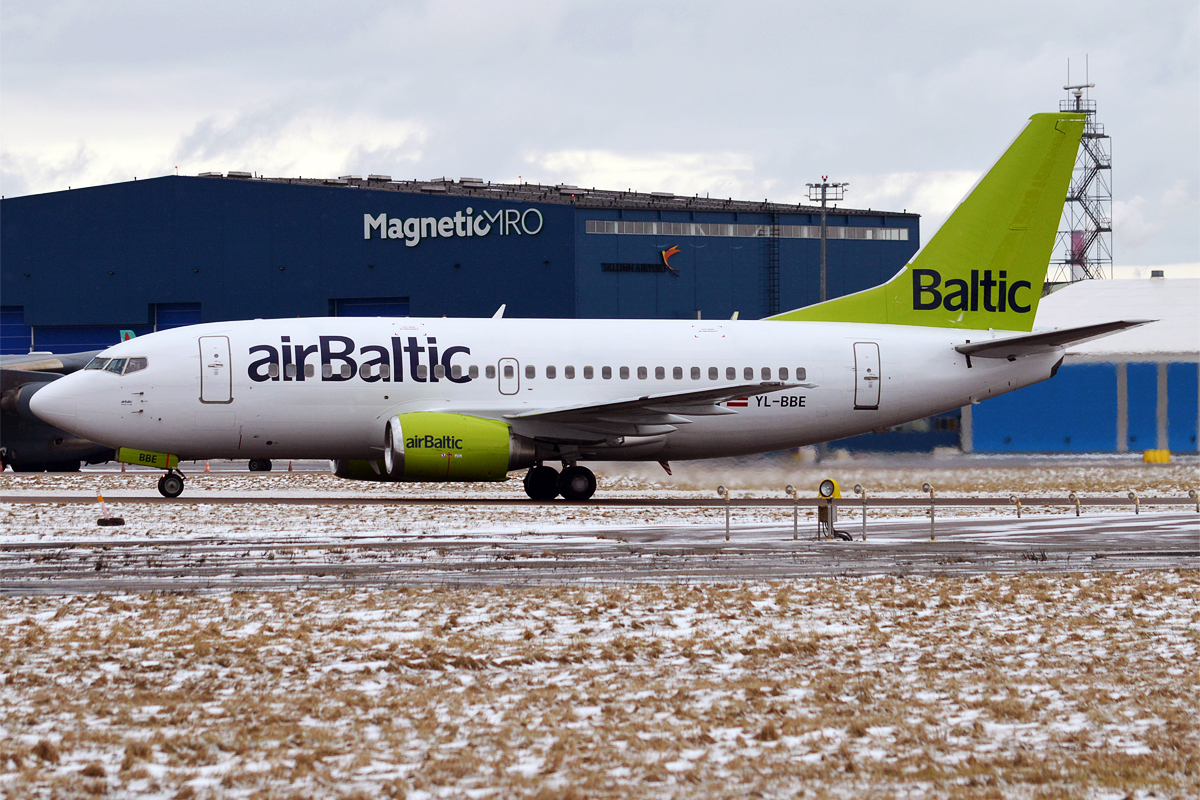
[34,318,1061,461]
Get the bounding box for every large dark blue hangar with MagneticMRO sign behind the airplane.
[0,173,919,354]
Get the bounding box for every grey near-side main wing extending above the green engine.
[504,381,816,435]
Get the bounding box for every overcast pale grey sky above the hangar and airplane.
[0,0,1200,275]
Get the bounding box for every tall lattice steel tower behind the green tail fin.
[1049,83,1112,284]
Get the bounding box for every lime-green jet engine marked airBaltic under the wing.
[334,411,534,481]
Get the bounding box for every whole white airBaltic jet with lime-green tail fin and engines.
[30,113,1152,501]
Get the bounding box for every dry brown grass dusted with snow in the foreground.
[0,571,1200,800]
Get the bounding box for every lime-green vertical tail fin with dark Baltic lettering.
[768,114,1085,331]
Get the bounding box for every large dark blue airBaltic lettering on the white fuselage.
[246,336,470,384]
